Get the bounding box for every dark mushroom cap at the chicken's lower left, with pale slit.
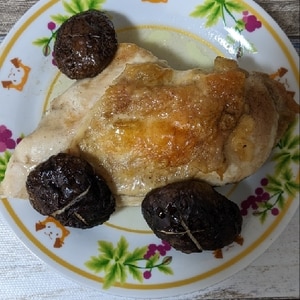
[26,153,115,228]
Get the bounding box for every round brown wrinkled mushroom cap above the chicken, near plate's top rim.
[54,10,118,79]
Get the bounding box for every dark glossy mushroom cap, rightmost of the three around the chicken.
[141,180,242,253]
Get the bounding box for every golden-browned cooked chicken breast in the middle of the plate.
[1,44,299,206]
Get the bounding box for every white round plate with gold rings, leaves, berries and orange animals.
[0,0,299,299]
